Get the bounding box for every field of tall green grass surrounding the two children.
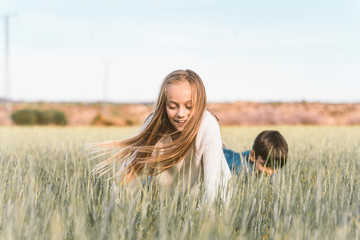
[0,126,360,240]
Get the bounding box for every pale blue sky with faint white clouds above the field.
[0,0,360,102]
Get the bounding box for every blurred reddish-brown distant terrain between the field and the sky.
[0,101,360,126]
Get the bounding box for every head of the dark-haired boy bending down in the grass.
[250,130,288,175]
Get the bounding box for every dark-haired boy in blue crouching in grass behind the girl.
[223,130,288,176]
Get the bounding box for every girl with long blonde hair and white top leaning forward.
[94,70,231,201]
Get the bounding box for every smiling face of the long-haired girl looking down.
[166,80,192,132]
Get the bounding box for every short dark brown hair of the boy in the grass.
[253,130,288,168]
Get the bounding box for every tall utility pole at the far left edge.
[2,14,16,124]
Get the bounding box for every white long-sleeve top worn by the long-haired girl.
[144,111,231,201]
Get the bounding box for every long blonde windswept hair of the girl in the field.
[93,70,207,182]
